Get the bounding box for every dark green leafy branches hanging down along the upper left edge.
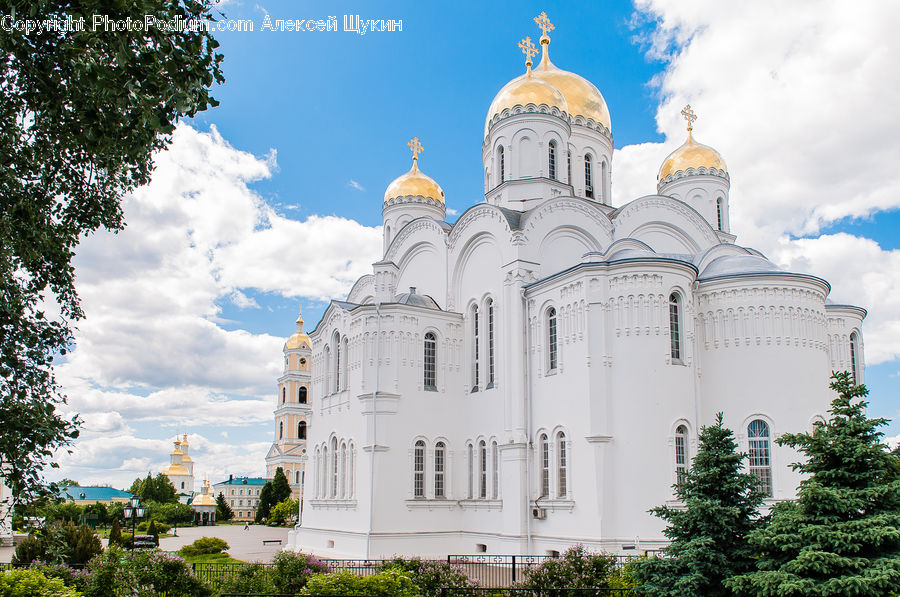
[0,0,224,496]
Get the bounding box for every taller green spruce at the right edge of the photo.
[729,372,900,597]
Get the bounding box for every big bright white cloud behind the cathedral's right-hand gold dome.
[613,0,900,364]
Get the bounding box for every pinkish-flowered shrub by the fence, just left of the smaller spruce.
[517,545,617,590]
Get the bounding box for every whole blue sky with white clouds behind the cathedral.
[54,0,900,485]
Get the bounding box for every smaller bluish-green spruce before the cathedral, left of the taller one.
[633,413,763,597]
